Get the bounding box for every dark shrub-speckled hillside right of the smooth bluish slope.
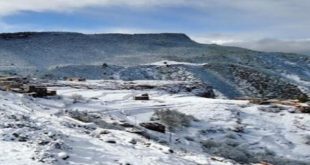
[206,64,305,99]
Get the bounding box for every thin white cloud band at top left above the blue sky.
[0,0,186,16]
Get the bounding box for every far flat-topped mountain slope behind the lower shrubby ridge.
[0,32,310,71]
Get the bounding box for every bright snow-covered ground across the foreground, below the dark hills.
[0,81,310,165]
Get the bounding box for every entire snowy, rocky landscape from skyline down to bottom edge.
[0,32,310,165]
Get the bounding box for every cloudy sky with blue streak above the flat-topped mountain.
[0,0,310,54]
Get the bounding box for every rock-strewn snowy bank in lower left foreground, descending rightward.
[0,80,235,165]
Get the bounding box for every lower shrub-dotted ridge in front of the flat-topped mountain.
[43,61,310,99]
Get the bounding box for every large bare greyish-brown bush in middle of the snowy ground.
[151,109,195,131]
